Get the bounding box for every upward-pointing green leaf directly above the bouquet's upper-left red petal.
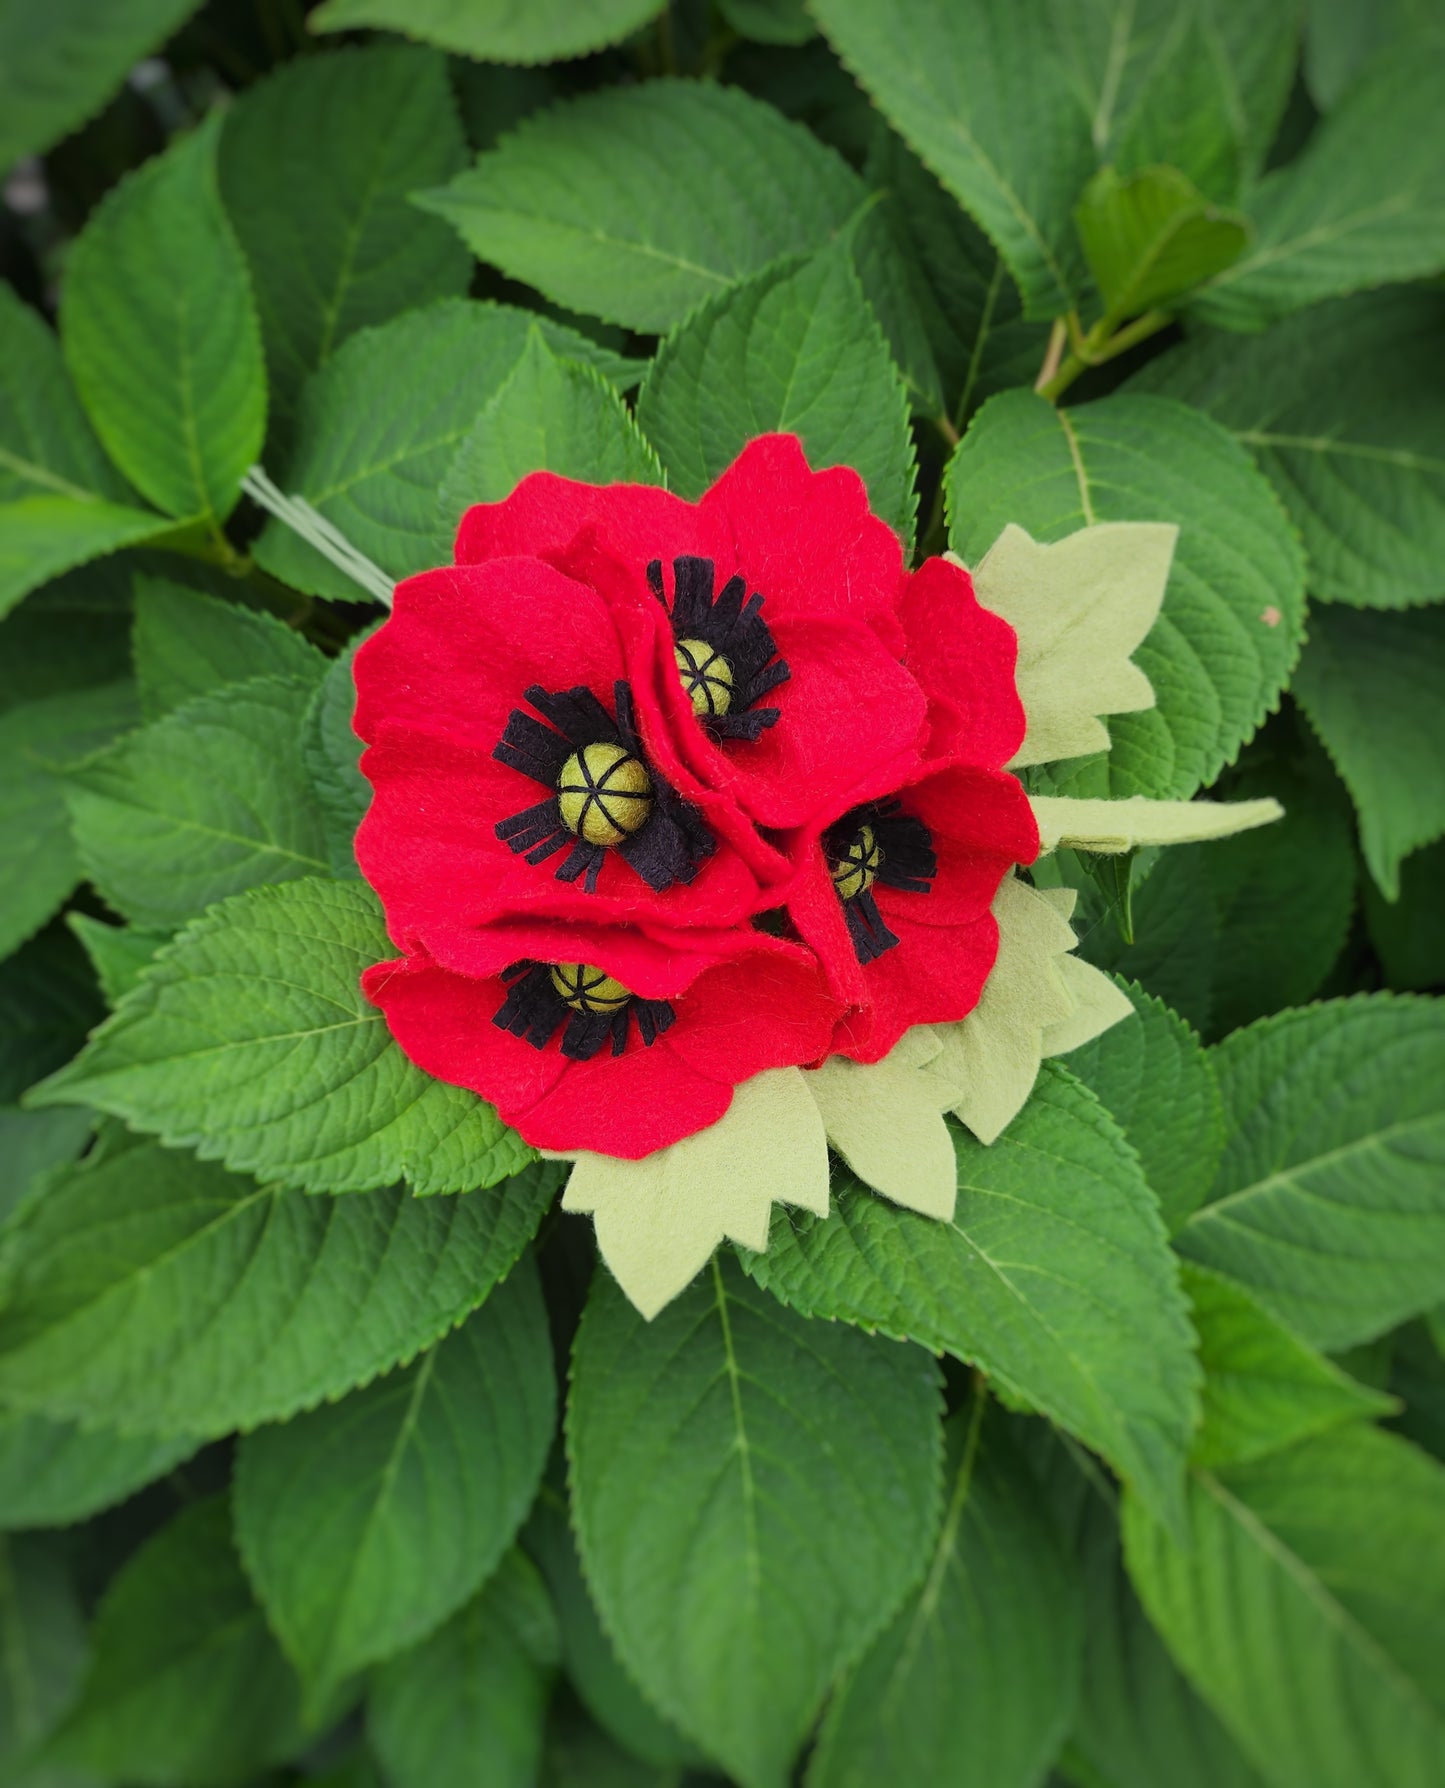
[436,329,662,539]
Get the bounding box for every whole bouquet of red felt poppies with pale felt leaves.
[354,434,1277,1312]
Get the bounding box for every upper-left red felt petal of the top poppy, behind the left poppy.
[445,472,715,569]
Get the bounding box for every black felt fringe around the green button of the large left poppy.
[492,681,717,894]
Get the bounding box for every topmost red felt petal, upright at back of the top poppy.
[699,434,903,651]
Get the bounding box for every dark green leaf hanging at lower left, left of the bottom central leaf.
[234,1259,556,1715]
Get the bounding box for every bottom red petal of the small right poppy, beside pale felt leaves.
[833,912,998,1062]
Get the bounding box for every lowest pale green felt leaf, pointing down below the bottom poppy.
[562,1067,828,1318]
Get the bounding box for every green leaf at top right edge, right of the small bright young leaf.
[1193,34,1445,329]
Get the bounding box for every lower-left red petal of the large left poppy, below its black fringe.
[356,726,758,949]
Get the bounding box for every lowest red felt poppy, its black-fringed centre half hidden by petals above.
[361,921,842,1160]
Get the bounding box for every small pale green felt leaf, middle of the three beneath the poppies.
[803,1026,964,1221]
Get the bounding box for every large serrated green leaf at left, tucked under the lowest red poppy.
[32,878,533,1193]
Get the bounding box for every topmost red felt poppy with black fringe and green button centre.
[456,434,925,828]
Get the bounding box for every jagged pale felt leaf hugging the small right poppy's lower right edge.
[937,876,1087,1143]
